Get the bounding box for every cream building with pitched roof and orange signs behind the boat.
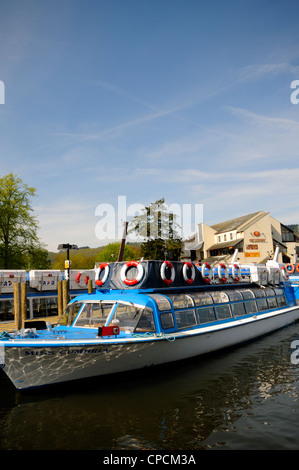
[184,211,299,264]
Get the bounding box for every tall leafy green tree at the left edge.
[0,173,42,269]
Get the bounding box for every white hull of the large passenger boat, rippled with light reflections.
[1,306,299,390]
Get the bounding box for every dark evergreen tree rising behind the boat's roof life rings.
[129,198,183,261]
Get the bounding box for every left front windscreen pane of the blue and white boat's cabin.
[75,302,115,328]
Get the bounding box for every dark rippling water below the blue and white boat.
[0,323,299,451]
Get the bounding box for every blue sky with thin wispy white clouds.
[0,0,299,251]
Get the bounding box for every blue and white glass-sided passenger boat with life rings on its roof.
[0,253,299,390]
